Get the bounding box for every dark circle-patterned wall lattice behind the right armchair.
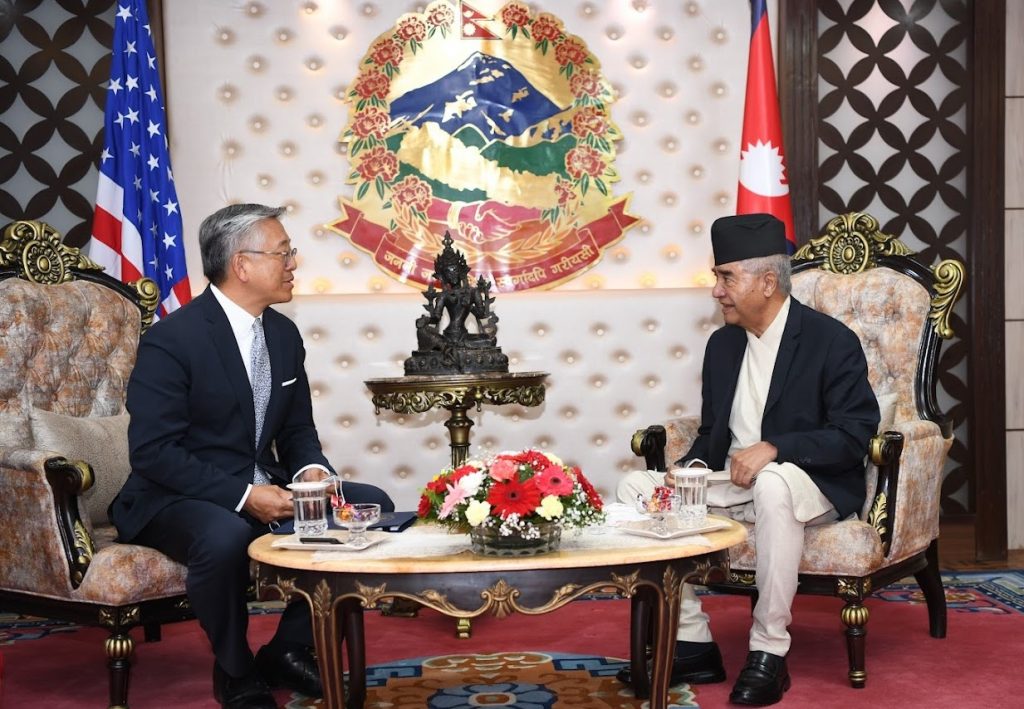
[818,0,973,513]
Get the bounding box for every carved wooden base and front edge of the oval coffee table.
[249,524,745,709]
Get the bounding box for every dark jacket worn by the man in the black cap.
[679,298,879,518]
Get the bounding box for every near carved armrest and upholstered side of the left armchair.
[0,447,95,597]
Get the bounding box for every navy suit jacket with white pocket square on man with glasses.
[110,288,331,542]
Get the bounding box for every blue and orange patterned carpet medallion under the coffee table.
[278,653,698,709]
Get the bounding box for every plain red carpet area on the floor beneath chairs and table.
[0,577,1024,709]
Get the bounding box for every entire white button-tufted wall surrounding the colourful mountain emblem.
[157,0,777,507]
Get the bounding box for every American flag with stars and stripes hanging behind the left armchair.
[88,0,191,317]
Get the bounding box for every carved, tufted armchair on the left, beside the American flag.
[0,221,191,707]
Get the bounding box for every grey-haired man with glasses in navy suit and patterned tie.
[111,204,394,709]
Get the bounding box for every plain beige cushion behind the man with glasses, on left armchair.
[29,409,131,528]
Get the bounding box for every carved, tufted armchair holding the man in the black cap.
[632,213,964,687]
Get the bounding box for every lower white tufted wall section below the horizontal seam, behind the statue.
[279,288,721,508]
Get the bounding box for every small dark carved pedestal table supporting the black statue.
[364,372,548,467]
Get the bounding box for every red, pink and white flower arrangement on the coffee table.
[417,450,604,554]
